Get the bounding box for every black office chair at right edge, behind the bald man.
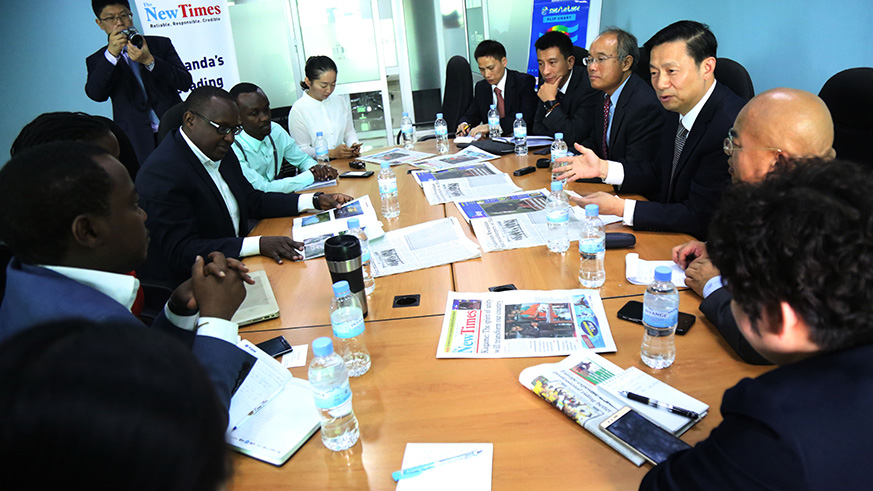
[818,67,873,165]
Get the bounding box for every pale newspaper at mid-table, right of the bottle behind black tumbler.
[370,217,481,277]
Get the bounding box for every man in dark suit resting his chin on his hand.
[531,31,600,146]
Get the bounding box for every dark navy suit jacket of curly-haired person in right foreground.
[640,345,873,490]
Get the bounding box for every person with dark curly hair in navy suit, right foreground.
[640,159,873,490]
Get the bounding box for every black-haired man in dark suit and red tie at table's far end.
[455,39,537,136]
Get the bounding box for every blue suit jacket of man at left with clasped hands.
[0,259,255,408]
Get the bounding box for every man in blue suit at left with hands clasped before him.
[0,141,254,407]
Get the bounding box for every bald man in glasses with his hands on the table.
[673,88,836,365]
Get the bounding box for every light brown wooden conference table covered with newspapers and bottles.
[229,141,767,490]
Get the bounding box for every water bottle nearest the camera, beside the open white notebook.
[309,338,360,452]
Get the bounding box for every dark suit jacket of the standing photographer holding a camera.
[85,36,192,162]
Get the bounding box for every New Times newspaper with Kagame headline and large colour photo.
[437,290,615,358]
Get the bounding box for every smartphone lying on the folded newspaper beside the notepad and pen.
[600,406,691,465]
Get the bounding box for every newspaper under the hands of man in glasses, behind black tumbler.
[291,195,385,260]
